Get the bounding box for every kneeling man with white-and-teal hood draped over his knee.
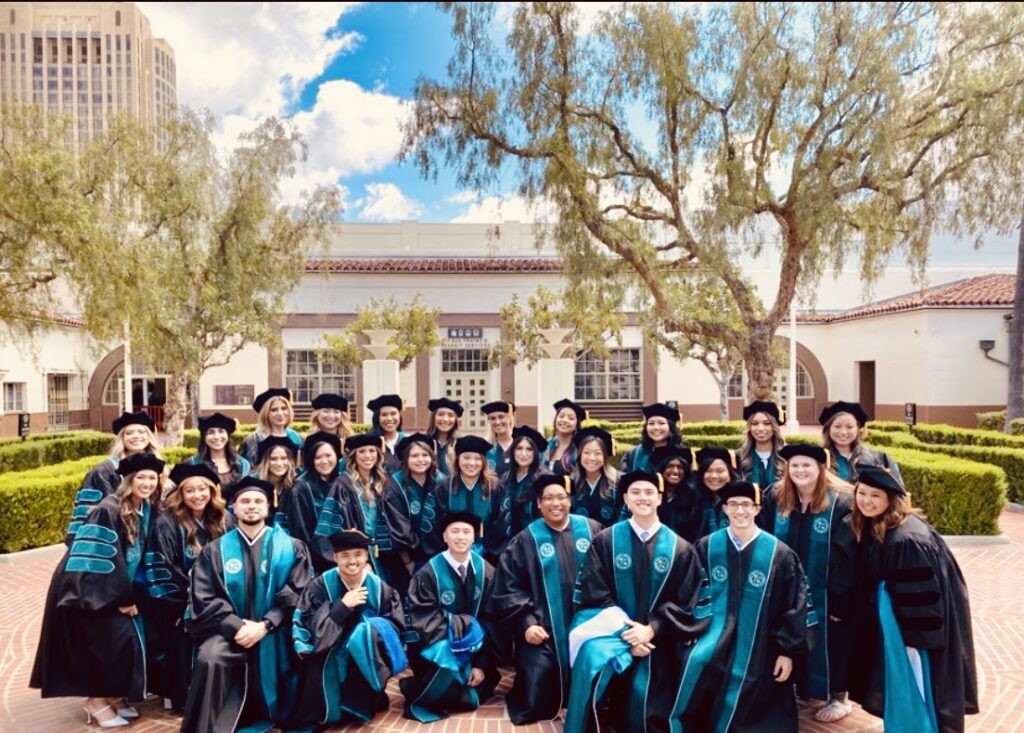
[565,471,708,733]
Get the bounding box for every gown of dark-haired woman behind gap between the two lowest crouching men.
[380,471,436,598]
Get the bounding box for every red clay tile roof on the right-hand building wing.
[798,272,1017,324]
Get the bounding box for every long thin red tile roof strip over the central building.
[306,257,562,274]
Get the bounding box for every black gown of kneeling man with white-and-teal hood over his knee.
[577,525,708,733]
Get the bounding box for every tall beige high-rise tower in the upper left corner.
[0,2,177,143]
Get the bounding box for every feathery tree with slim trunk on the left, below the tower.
[75,111,340,445]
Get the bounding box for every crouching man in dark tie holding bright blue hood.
[399,512,501,723]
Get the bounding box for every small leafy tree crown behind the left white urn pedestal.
[321,293,441,369]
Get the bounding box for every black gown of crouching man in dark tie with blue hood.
[398,560,502,717]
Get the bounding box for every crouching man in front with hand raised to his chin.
[292,528,407,725]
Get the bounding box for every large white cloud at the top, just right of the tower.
[139,2,361,118]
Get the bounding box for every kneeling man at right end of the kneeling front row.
[672,481,807,733]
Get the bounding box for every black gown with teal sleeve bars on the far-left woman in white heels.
[29,497,147,700]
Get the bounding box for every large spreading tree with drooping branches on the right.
[400,2,1024,398]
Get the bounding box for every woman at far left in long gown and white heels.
[30,452,164,728]
